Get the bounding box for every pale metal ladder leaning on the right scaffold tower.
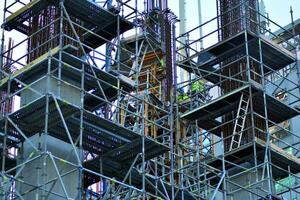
[229,93,250,151]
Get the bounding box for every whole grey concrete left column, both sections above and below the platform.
[16,62,81,200]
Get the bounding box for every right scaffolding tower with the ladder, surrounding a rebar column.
[176,0,300,200]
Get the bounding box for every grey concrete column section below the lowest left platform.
[16,135,79,200]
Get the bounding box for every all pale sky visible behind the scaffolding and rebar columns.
[0,0,300,67]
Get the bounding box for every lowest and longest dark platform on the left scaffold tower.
[0,96,168,160]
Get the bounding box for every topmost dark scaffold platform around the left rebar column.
[3,0,133,48]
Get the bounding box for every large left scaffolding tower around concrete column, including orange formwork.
[0,0,180,199]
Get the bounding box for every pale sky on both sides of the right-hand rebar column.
[169,0,300,50]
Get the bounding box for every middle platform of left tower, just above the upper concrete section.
[0,45,135,110]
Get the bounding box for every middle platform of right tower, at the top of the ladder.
[181,83,300,136]
